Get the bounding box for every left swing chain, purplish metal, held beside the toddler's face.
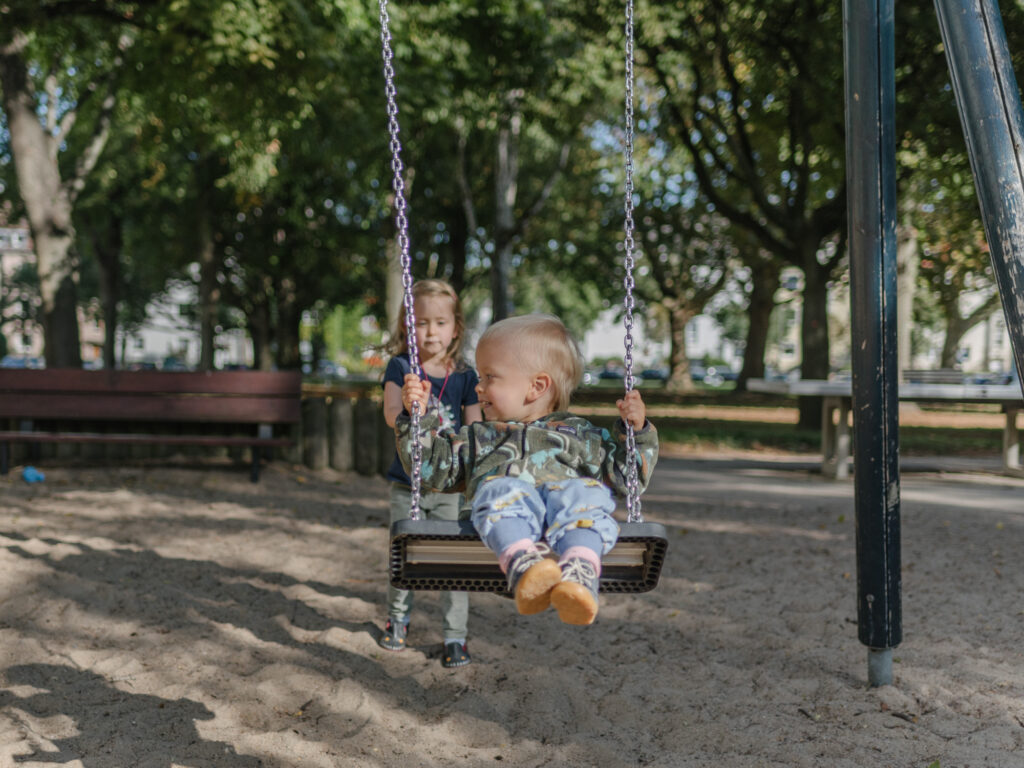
[380,0,423,520]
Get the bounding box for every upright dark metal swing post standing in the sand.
[843,0,903,686]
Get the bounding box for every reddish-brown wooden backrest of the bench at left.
[0,369,302,424]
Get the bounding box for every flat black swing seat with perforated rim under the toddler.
[389,520,669,597]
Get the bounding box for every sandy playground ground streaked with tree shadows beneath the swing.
[0,457,1024,768]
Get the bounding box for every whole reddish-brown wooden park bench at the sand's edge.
[0,369,302,482]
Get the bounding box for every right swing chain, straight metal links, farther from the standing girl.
[623,0,643,522]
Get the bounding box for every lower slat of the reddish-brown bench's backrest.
[0,391,302,424]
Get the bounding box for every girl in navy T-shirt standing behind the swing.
[378,280,482,667]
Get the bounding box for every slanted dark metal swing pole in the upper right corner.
[935,0,1024,382]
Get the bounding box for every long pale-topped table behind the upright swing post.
[746,379,1024,479]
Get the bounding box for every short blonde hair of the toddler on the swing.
[477,314,583,411]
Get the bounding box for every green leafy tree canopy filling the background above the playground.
[0,0,1024,386]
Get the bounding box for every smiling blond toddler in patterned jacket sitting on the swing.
[395,314,657,625]
